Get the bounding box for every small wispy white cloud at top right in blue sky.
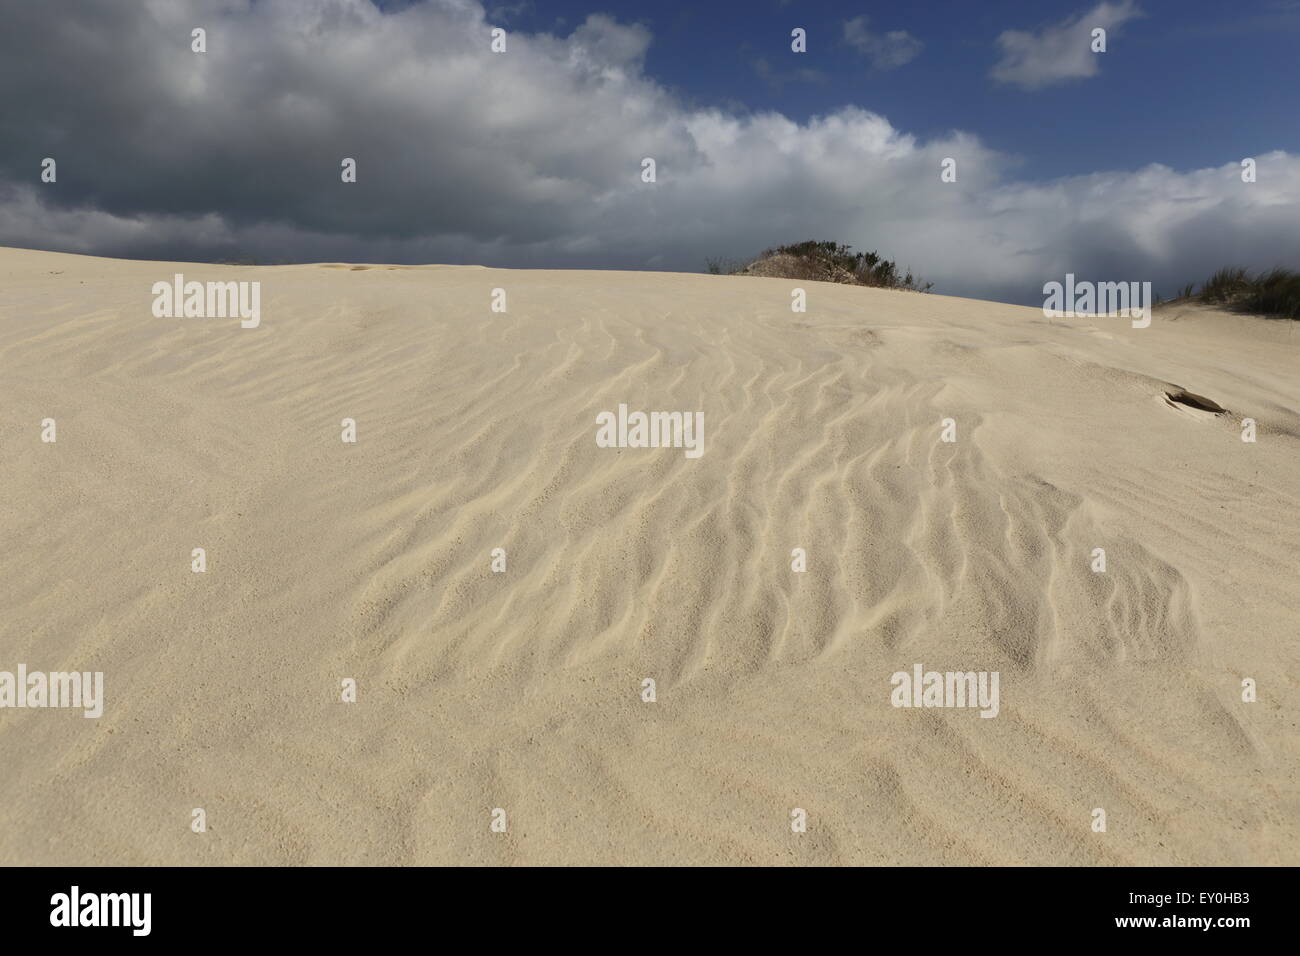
[992,0,1141,90]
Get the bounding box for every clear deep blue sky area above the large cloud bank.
[488,0,1300,178]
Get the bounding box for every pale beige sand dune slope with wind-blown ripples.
[0,250,1300,864]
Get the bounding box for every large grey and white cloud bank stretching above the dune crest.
[0,0,1300,303]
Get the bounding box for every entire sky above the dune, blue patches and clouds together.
[0,0,1300,304]
